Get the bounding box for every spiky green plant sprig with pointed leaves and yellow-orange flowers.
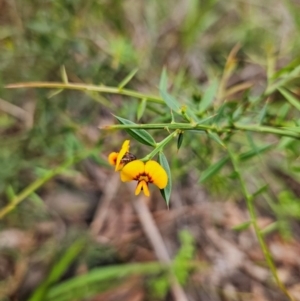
[2,61,300,300]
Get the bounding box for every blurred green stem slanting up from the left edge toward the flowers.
[0,149,95,219]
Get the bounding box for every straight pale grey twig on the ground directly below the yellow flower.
[133,192,188,301]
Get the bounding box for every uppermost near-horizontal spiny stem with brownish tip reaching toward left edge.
[5,82,165,104]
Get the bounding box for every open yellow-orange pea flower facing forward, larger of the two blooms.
[121,160,168,196]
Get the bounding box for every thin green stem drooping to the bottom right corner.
[227,146,294,301]
